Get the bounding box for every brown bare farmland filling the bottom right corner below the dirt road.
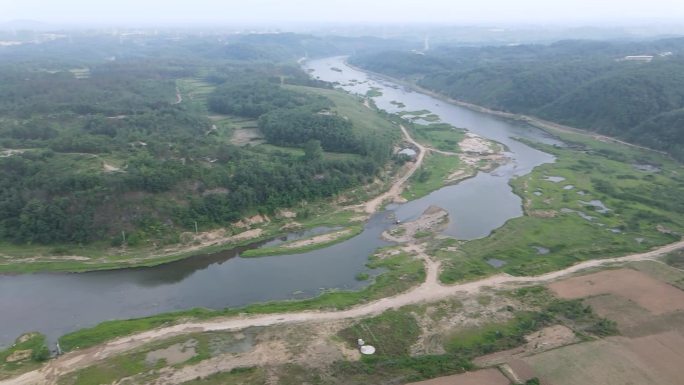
[524,262,684,385]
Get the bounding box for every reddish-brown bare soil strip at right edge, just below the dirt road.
[549,269,684,314]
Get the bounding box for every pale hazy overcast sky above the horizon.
[0,0,684,25]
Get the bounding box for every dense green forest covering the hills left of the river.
[0,34,392,246]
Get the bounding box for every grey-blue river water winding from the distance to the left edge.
[0,57,560,347]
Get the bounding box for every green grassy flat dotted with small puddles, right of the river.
[436,136,684,283]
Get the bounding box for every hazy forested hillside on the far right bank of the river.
[351,38,684,160]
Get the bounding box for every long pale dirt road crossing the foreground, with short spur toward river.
[5,240,684,385]
